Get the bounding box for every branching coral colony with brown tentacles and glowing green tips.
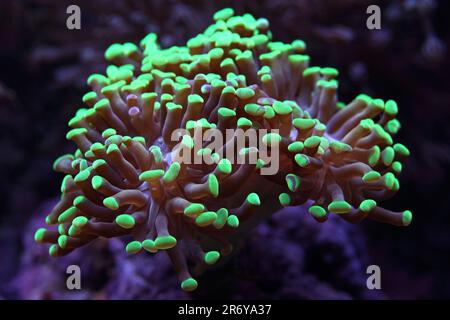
[35,8,412,291]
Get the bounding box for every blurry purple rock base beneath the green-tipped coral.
[9,199,383,300]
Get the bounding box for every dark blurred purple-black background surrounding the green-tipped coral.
[0,0,450,299]
